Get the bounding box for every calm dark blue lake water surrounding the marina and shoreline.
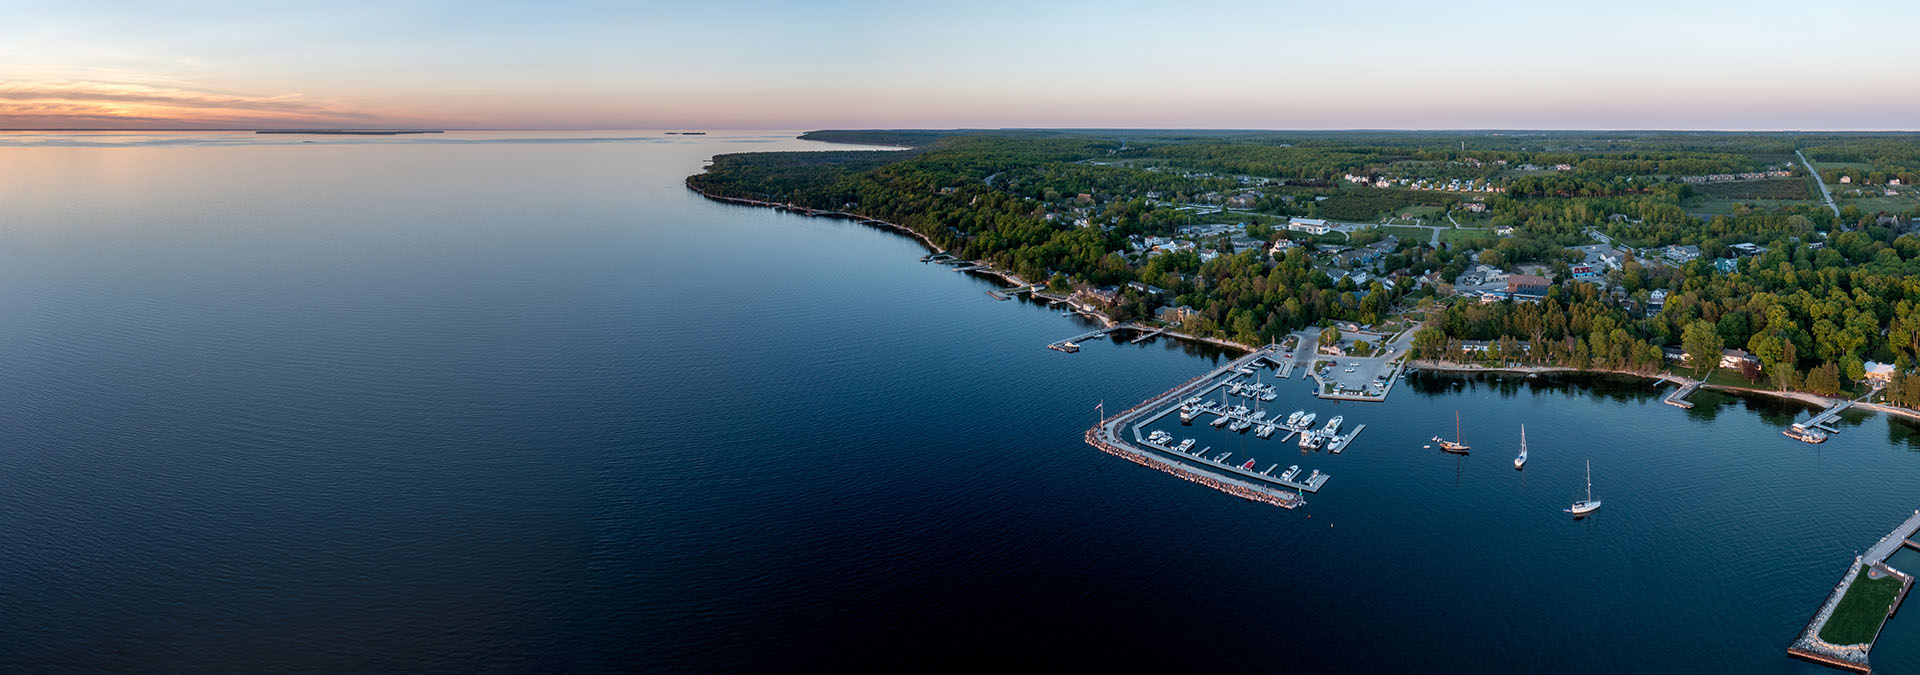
[0,132,1920,673]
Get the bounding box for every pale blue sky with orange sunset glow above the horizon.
[0,0,1920,130]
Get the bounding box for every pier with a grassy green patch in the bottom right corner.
[1788,510,1920,673]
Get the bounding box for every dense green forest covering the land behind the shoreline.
[687,130,1920,399]
